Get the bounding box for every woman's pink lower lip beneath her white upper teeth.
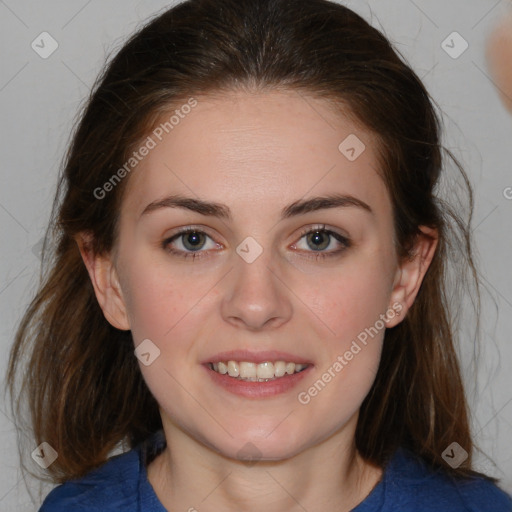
[203,364,313,398]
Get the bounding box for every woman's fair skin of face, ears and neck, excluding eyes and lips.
[78,91,436,512]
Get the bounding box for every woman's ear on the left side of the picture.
[75,233,130,330]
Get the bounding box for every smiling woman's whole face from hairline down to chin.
[104,91,416,459]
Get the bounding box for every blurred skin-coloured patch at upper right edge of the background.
[487,13,512,114]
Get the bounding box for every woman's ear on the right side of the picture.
[386,226,439,327]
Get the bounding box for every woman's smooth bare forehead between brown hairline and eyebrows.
[123,91,389,220]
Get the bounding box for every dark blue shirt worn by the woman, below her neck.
[39,432,512,512]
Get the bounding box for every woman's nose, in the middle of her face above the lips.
[221,245,293,331]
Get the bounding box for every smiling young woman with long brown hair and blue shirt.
[10,0,512,512]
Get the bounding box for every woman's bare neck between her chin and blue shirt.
[148,417,382,512]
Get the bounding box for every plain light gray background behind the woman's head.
[0,0,512,512]
